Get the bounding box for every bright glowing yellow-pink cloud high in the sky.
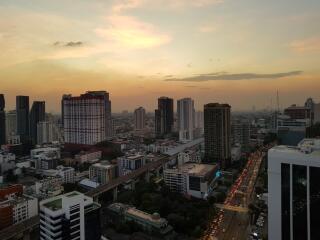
[95,15,171,49]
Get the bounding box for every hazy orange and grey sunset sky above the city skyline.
[0,0,320,112]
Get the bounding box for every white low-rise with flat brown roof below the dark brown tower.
[164,163,219,199]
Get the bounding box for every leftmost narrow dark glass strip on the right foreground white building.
[281,163,290,240]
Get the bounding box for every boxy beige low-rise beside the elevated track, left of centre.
[89,161,117,184]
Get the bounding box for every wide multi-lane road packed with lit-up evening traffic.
[202,146,271,240]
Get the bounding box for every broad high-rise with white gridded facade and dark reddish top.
[62,91,112,145]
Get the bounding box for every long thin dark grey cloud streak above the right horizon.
[164,71,302,82]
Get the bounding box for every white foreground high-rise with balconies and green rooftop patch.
[39,191,101,240]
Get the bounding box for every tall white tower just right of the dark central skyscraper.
[177,98,195,142]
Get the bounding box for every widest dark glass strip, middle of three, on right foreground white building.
[292,165,308,240]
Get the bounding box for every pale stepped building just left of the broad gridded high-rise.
[37,121,63,144]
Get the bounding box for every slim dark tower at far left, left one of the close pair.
[16,96,29,143]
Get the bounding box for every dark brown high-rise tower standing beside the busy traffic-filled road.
[204,103,231,168]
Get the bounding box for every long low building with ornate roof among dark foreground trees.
[108,203,173,237]
